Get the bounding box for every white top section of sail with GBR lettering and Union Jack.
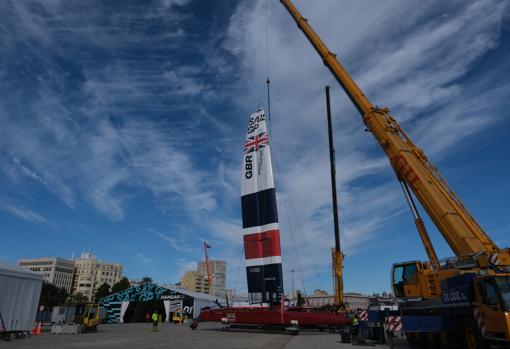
[241,109,274,196]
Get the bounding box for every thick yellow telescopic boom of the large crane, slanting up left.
[280,0,510,265]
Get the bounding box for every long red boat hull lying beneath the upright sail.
[199,307,352,327]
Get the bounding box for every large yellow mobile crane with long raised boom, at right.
[280,0,510,349]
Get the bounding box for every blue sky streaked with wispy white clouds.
[0,0,510,293]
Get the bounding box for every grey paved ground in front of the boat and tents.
[0,323,414,349]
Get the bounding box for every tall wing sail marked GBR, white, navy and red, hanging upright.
[241,110,283,303]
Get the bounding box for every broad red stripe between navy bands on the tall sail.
[243,229,282,259]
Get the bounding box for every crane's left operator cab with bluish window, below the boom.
[391,261,430,298]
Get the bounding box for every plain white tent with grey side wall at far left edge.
[0,261,43,331]
